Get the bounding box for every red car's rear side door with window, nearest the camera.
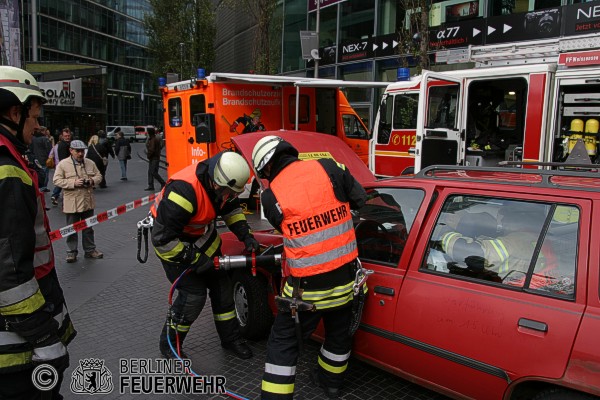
[393,190,591,399]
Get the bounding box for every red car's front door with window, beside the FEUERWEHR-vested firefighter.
[354,187,430,366]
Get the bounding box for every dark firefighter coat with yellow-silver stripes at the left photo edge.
[0,126,75,373]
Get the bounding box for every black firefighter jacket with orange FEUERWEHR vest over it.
[261,150,366,310]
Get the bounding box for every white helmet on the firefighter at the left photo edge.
[0,66,46,106]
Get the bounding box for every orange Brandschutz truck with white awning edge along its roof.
[159,69,387,176]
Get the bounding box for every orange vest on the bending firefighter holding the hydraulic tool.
[150,164,217,236]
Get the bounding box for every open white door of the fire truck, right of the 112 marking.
[415,71,465,172]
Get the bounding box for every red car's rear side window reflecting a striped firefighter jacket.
[423,196,579,298]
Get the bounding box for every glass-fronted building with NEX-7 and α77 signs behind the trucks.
[215,0,600,131]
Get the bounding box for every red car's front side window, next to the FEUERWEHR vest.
[354,188,425,267]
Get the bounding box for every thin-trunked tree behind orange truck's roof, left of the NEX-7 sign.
[221,0,281,74]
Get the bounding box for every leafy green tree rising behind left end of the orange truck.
[143,0,216,79]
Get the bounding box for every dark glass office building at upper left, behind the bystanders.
[21,0,162,137]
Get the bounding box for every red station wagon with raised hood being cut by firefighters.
[223,132,600,400]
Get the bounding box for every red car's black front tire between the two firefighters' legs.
[233,271,274,340]
